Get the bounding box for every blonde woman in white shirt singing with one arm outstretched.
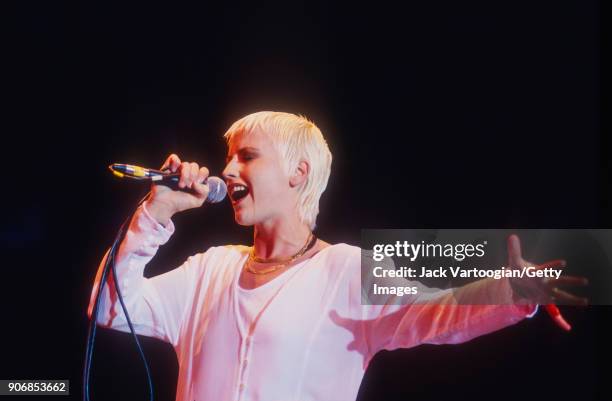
[90,112,584,401]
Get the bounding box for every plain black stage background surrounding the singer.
[0,0,612,401]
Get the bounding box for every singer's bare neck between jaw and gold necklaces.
[253,212,310,259]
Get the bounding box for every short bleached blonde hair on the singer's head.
[224,111,332,230]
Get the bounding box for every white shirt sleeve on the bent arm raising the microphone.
[88,202,200,346]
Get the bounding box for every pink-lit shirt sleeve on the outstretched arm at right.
[351,250,538,356]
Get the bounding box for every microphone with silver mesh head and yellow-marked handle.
[108,163,227,203]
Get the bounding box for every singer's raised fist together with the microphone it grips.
[111,154,227,225]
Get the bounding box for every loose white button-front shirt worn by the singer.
[90,205,536,401]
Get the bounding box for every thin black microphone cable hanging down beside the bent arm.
[83,192,154,401]
